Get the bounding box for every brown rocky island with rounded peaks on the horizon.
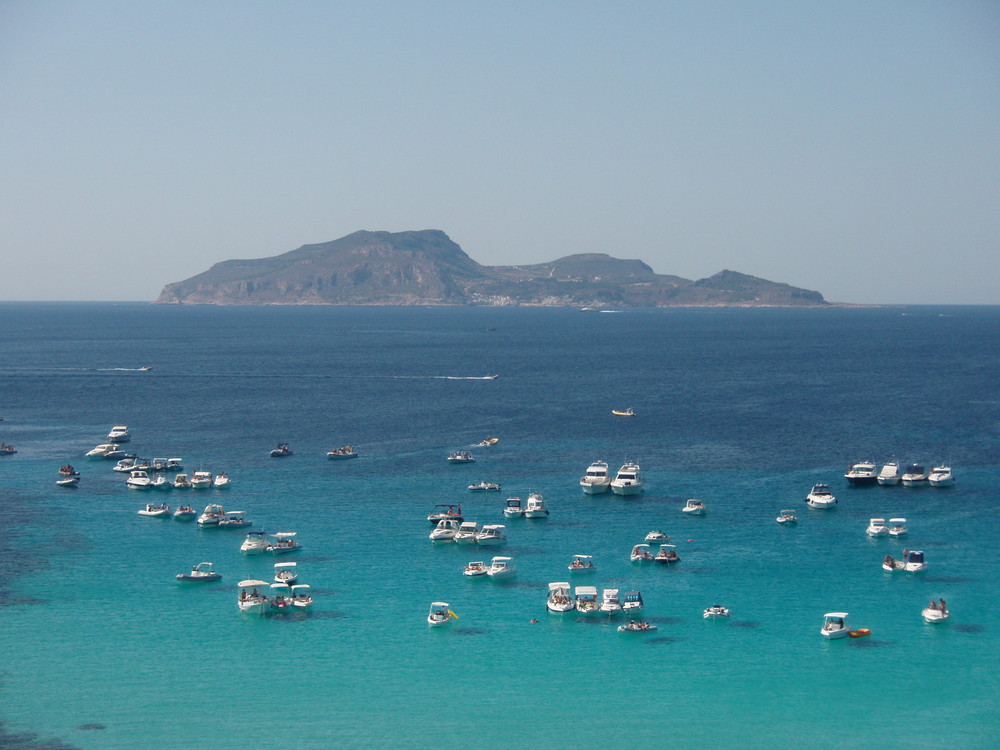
[156,229,827,307]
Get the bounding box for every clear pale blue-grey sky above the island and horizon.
[0,0,1000,304]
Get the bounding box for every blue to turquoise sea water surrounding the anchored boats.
[0,303,1000,750]
